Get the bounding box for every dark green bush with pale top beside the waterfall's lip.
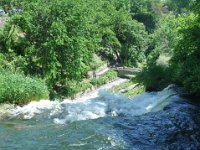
[135,53,172,91]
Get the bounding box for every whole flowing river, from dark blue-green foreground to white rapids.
[0,79,200,150]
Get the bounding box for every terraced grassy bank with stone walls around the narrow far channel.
[63,67,145,100]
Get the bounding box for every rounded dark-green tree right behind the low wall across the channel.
[114,18,148,66]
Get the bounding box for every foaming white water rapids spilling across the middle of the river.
[0,79,175,124]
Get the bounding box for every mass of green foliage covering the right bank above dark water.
[134,0,200,96]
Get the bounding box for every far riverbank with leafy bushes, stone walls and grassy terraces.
[0,51,144,105]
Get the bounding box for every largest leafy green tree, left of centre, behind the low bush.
[6,0,97,86]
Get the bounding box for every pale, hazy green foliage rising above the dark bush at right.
[149,14,181,56]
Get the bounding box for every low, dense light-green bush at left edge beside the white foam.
[0,70,49,104]
